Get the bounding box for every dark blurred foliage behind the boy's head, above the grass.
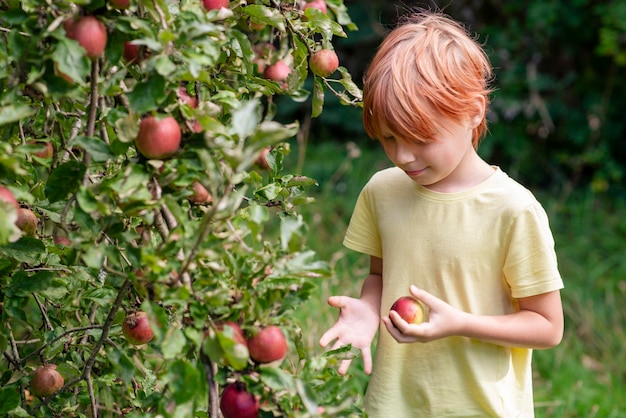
[282,0,626,199]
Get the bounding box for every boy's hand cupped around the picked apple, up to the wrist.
[382,285,467,343]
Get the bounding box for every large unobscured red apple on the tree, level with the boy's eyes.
[135,116,182,160]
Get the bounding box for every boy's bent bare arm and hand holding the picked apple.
[382,286,563,349]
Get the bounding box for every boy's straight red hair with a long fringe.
[363,12,492,147]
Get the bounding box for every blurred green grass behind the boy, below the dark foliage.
[286,143,626,418]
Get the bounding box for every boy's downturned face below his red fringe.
[381,119,476,191]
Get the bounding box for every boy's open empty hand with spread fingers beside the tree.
[320,296,380,375]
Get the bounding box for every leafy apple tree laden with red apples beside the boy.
[0,0,360,418]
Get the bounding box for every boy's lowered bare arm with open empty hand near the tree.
[320,257,383,374]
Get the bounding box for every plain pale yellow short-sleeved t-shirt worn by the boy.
[344,167,563,418]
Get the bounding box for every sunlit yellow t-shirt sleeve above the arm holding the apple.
[504,203,563,298]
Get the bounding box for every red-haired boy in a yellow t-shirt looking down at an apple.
[320,12,563,418]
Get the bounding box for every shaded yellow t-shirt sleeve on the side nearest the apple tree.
[343,185,383,257]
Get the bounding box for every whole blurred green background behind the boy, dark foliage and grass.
[278,0,626,417]
